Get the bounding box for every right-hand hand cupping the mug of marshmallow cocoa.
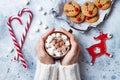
[60,28,80,65]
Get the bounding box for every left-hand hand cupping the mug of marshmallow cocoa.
[35,28,55,64]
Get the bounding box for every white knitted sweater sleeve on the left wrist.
[34,61,58,80]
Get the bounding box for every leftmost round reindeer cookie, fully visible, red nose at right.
[63,1,80,17]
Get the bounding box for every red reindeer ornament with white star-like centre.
[87,30,112,65]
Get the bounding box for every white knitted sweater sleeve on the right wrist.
[59,63,81,80]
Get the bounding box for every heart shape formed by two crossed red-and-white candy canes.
[7,8,33,68]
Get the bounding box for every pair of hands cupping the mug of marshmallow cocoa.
[35,28,80,65]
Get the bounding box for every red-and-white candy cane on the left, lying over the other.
[7,16,27,68]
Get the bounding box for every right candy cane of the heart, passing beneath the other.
[14,8,33,60]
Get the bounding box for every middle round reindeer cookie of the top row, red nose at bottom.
[81,1,98,17]
